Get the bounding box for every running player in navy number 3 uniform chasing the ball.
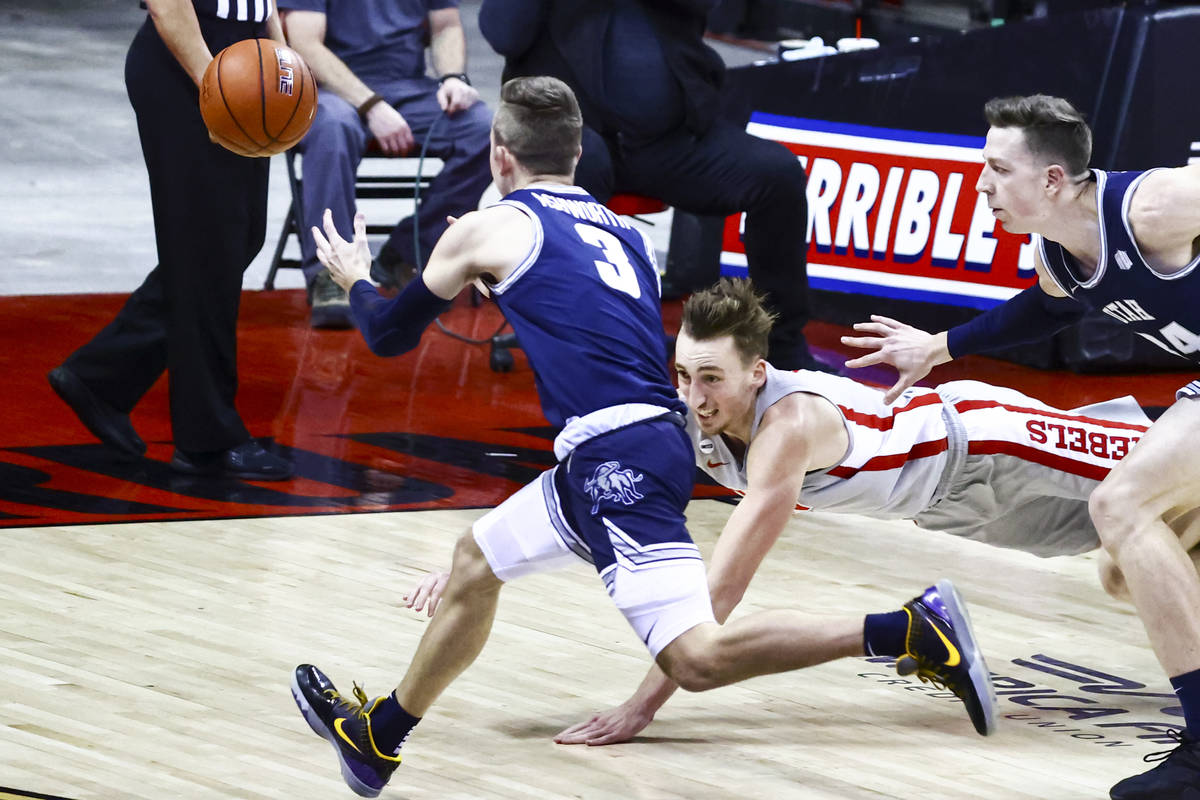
[292,78,995,796]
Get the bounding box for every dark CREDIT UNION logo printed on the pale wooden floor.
[858,654,1183,747]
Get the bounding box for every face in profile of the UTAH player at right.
[976,128,1049,234]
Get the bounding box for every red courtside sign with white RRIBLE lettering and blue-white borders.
[721,112,1034,308]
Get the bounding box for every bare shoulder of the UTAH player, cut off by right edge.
[1129,164,1200,273]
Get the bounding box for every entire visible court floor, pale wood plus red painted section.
[0,291,1188,800]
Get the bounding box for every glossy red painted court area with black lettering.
[0,290,1180,527]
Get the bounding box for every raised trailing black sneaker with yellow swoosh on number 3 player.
[896,581,996,736]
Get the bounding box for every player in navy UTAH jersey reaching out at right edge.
[842,95,1200,800]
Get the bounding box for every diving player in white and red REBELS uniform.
[406,278,1161,745]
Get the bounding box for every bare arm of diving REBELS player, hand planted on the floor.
[554,395,816,745]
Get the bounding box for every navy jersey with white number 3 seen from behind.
[492,184,686,426]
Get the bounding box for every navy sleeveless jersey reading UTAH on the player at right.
[1042,169,1200,361]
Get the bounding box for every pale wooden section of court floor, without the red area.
[0,500,1174,800]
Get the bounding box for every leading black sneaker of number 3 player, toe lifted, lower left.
[292,664,403,798]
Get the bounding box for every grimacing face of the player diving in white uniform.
[676,331,763,437]
